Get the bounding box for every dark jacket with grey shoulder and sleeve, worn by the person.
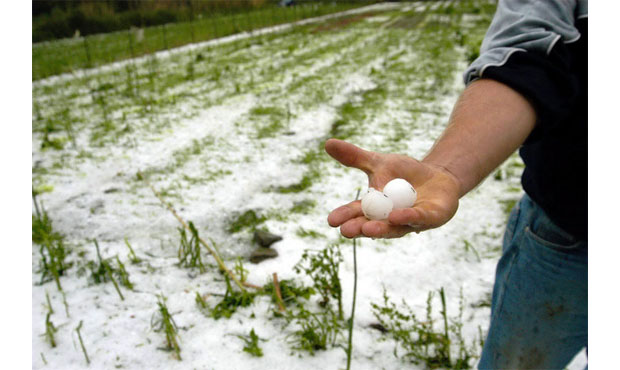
[464,0,588,239]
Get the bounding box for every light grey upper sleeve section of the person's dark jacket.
[463,0,587,84]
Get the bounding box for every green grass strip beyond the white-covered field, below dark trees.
[32,3,359,80]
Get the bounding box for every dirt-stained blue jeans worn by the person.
[478,195,588,369]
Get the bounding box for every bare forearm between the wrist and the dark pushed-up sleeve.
[422,79,536,197]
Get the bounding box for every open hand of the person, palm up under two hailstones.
[325,139,460,238]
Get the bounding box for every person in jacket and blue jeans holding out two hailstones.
[325,0,588,369]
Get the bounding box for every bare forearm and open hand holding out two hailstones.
[325,79,536,238]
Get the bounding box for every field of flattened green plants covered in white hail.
[32,1,588,369]
